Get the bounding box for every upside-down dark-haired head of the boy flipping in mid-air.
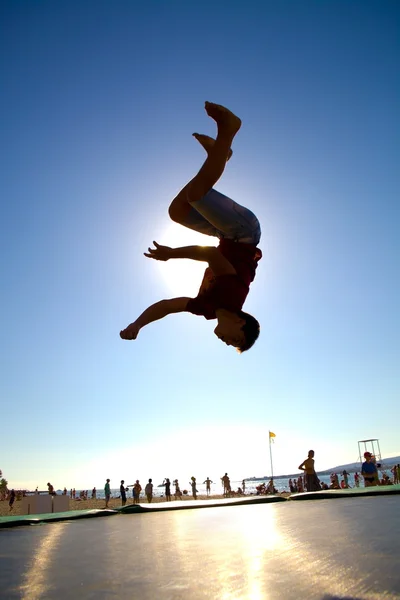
[214,310,260,354]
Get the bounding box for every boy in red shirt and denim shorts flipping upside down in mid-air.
[120,102,261,352]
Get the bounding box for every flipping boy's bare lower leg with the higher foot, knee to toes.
[169,102,241,225]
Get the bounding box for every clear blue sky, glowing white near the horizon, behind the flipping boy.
[0,0,400,488]
